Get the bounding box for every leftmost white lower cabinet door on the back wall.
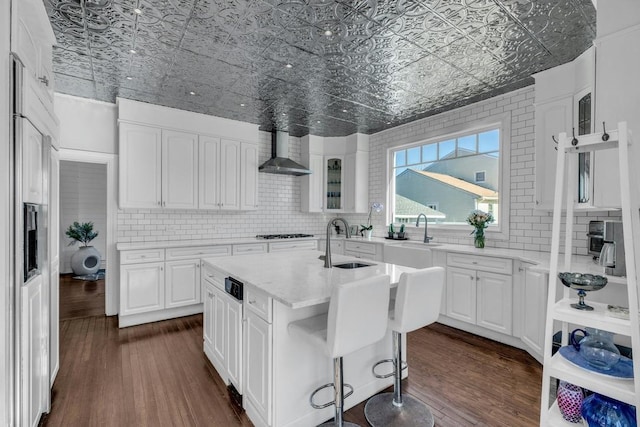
[120,262,165,320]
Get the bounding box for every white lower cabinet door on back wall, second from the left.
[165,259,200,308]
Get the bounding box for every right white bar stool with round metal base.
[364,267,444,427]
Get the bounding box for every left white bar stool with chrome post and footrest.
[288,276,390,426]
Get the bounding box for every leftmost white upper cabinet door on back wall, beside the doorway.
[119,123,162,208]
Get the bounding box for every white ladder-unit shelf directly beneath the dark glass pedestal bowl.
[552,298,631,336]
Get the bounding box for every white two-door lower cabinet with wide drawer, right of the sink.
[446,254,513,335]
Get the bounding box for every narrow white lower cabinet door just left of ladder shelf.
[521,268,548,360]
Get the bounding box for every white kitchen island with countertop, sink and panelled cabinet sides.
[202,251,413,427]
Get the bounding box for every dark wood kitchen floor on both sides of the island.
[41,315,542,427]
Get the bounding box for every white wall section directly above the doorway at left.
[55,93,118,154]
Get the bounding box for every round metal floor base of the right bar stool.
[364,393,435,427]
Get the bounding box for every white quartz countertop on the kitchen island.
[203,251,414,308]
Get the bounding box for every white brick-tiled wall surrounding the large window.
[369,86,619,255]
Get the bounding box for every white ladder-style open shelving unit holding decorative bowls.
[540,122,640,426]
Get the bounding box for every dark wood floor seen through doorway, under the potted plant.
[60,274,105,320]
